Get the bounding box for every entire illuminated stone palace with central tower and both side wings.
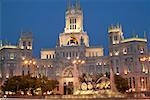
[0,0,150,94]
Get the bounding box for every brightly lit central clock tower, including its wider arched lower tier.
[59,0,89,47]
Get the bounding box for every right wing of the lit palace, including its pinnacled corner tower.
[108,25,150,92]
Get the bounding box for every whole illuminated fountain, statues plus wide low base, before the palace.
[74,74,124,98]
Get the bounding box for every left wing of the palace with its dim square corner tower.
[0,32,32,82]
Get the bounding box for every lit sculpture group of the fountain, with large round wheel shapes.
[75,74,120,96]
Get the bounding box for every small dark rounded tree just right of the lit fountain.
[114,75,129,93]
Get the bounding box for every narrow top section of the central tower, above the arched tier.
[64,0,83,33]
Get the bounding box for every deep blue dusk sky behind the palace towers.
[0,0,150,56]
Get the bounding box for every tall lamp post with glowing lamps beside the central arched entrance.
[72,58,85,92]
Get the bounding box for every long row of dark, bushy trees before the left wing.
[2,75,58,95]
